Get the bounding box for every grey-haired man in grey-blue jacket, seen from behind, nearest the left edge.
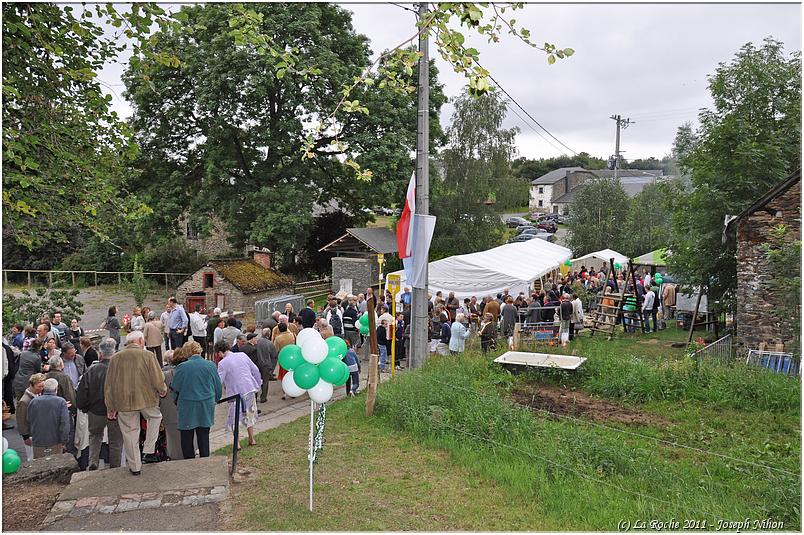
[28,379,70,459]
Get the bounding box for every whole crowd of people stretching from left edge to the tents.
[3,267,676,474]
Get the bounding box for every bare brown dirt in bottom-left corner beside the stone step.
[3,482,67,532]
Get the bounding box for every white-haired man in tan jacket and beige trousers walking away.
[103,331,167,476]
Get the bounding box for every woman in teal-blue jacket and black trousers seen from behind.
[170,341,223,459]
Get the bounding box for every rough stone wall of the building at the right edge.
[735,181,801,354]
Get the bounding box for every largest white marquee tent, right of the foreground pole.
[386,238,572,300]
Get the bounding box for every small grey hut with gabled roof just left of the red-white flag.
[319,228,397,295]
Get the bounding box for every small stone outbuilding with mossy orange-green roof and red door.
[176,248,293,312]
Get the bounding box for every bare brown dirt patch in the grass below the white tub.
[511,385,669,426]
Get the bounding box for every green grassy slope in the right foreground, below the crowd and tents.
[223,329,801,531]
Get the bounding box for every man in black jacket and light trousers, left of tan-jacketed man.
[76,338,123,470]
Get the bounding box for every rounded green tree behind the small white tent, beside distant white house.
[567,177,629,257]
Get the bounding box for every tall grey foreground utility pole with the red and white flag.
[408,2,430,369]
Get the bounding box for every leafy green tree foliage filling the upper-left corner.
[3,3,177,251]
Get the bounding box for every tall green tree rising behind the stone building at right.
[669,38,801,300]
